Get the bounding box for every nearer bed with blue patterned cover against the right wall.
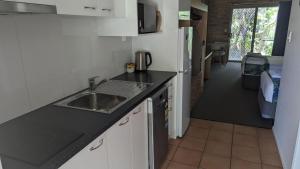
[258,57,282,119]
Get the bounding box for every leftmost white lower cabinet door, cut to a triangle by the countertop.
[59,134,109,169]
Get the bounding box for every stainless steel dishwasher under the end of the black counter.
[148,86,168,169]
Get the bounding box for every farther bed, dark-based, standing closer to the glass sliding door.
[242,53,269,90]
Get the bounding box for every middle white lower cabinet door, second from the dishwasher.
[107,114,132,169]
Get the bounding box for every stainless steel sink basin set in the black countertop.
[56,92,126,113]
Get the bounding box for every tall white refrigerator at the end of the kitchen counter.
[176,27,193,137]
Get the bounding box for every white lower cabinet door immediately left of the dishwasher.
[131,102,148,169]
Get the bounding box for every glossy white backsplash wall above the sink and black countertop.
[0,15,131,123]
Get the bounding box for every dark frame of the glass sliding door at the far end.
[228,2,279,62]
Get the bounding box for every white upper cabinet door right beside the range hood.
[57,0,99,16]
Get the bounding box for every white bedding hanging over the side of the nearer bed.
[260,72,274,103]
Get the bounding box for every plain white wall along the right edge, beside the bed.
[273,0,300,169]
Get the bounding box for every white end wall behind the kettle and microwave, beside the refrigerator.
[132,0,179,71]
